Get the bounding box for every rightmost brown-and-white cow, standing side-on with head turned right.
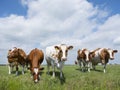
[90,48,118,73]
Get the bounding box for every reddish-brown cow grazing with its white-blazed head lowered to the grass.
[27,48,44,83]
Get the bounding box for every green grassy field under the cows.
[0,65,120,90]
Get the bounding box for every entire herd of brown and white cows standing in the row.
[7,44,118,82]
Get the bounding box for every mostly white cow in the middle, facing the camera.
[45,44,73,79]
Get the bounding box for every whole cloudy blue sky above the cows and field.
[0,0,120,64]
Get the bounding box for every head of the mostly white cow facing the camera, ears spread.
[54,44,73,61]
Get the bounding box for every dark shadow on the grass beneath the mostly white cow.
[46,71,66,85]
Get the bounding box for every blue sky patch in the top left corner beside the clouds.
[0,0,27,17]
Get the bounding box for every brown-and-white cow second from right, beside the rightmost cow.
[75,48,91,72]
